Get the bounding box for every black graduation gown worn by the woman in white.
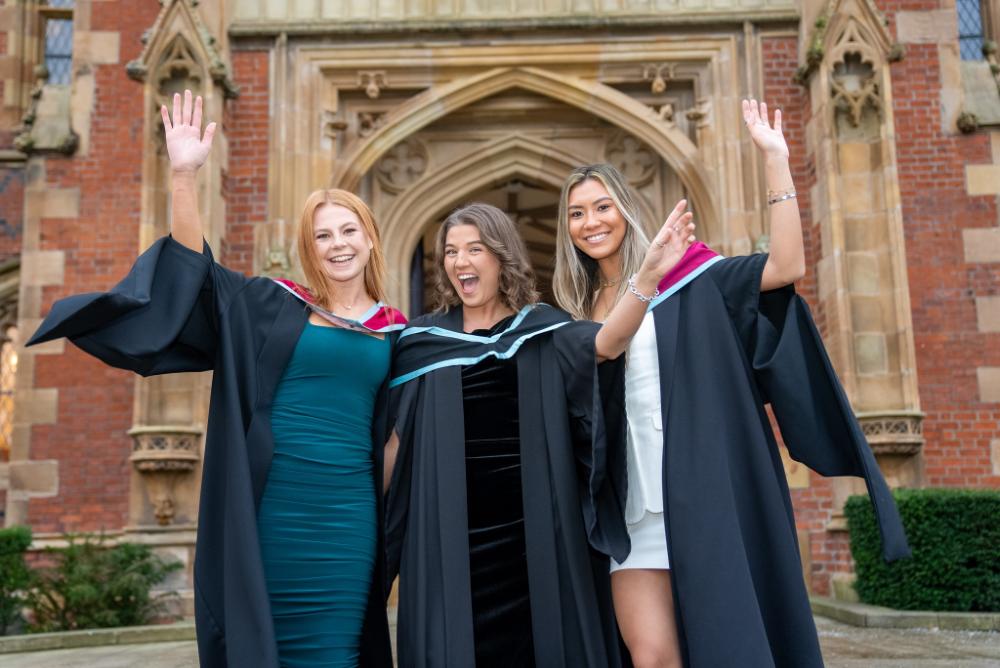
[595,255,909,668]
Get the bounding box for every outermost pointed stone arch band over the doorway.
[330,67,722,243]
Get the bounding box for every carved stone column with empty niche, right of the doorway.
[800,0,923,516]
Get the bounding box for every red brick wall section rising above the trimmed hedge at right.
[879,0,1000,487]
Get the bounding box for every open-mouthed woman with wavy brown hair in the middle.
[386,204,690,668]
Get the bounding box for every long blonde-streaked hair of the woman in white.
[552,164,649,320]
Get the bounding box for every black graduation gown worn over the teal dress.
[28,237,394,668]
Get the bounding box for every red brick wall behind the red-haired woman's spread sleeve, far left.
[29,0,160,532]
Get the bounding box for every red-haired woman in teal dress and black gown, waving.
[29,91,405,668]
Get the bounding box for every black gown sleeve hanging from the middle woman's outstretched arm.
[553,321,629,561]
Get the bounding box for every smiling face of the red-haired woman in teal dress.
[313,204,372,283]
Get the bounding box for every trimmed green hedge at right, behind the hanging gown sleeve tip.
[844,489,1000,612]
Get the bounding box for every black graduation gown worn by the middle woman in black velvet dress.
[386,305,621,668]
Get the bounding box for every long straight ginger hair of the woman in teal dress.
[299,189,386,309]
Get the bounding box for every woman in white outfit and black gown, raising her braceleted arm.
[554,100,908,668]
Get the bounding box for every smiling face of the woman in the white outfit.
[566,179,628,261]
